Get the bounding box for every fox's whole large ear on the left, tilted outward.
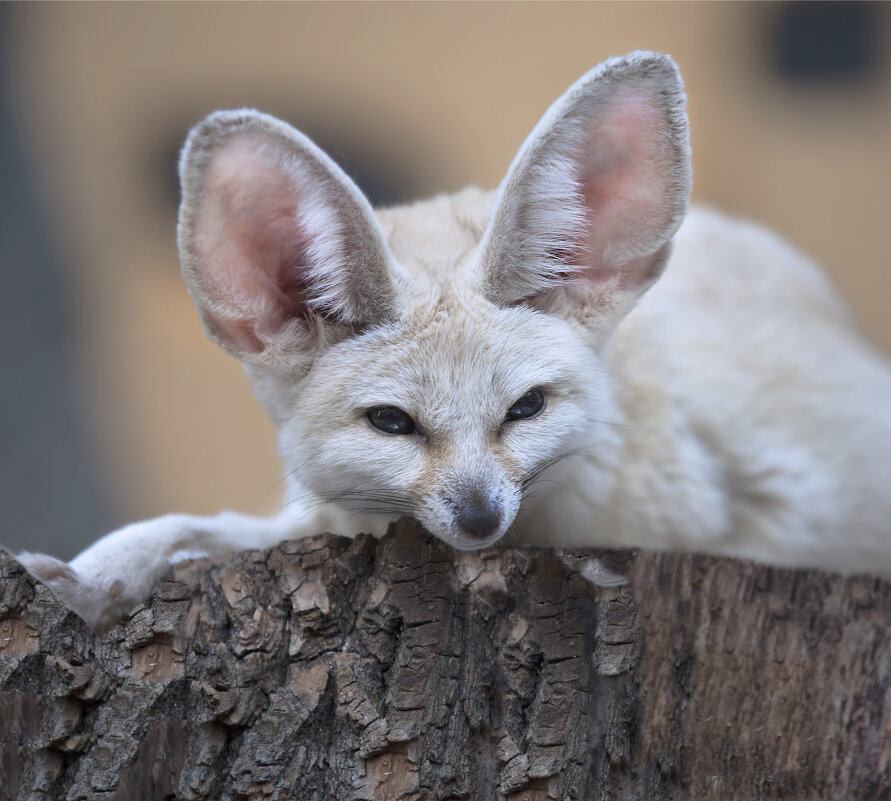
[179,110,395,370]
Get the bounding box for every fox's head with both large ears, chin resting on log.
[179,53,690,549]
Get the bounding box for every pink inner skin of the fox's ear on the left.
[195,135,318,353]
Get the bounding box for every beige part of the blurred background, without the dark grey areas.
[7,2,891,534]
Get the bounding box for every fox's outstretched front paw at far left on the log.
[16,552,135,634]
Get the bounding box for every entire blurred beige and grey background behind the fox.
[0,2,891,558]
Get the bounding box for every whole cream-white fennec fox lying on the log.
[21,52,891,625]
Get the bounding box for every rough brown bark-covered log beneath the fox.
[0,524,891,801]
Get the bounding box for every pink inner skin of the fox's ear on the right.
[573,91,671,288]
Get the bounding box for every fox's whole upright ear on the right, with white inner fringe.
[480,52,691,334]
